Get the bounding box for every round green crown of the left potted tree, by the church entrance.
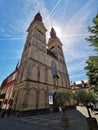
[55,92,71,108]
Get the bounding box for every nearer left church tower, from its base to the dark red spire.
[13,13,48,111]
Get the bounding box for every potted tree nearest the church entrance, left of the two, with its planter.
[55,92,70,126]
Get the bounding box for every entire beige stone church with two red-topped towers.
[12,13,71,113]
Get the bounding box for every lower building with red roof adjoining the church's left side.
[0,67,18,110]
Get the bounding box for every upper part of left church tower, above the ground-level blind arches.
[17,13,47,82]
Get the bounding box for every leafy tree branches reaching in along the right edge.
[85,14,98,94]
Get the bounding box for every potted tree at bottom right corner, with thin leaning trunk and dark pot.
[75,90,98,130]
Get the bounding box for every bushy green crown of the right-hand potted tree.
[75,90,94,106]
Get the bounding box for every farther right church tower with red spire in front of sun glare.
[47,27,70,88]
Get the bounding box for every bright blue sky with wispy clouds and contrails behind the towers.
[0,0,98,84]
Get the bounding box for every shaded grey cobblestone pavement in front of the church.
[6,109,89,130]
